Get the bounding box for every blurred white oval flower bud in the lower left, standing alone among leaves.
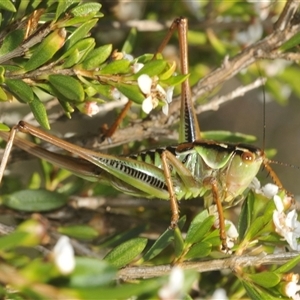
[53,236,75,275]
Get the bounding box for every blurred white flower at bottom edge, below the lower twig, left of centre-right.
[158,266,184,300]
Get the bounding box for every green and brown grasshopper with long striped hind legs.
[0,18,282,249]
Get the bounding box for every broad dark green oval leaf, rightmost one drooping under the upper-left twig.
[49,74,85,102]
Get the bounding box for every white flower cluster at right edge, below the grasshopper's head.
[273,195,300,251]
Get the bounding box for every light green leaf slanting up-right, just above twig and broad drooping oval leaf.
[82,44,112,70]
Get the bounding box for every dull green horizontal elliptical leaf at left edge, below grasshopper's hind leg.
[0,189,68,212]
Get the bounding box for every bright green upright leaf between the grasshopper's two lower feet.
[185,210,215,244]
